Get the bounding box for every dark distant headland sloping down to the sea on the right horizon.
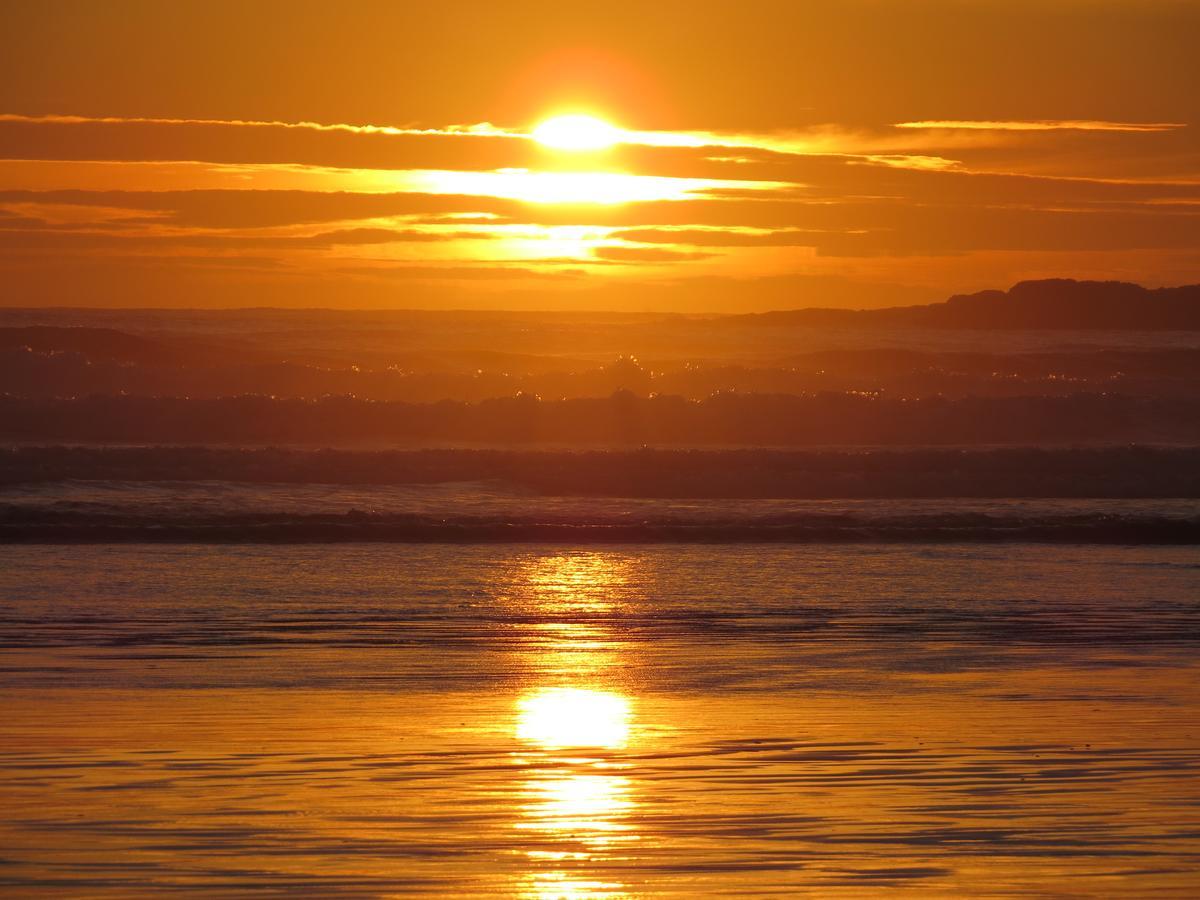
[739,278,1200,331]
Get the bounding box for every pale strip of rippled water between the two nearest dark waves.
[9,480,1200,523]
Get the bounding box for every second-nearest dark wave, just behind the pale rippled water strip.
[0,445,1200,498]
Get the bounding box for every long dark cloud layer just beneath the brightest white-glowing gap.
[0,187,1200,262]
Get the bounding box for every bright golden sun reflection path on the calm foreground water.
[514,554,638,900]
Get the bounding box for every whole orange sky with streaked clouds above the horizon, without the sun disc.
[0,0,1200,312]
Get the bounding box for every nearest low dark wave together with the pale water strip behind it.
[0,480,1200,545]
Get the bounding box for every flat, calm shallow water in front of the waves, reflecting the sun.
[0,545,1200,899]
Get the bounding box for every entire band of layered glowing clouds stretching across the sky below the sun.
[0,103,1200,297]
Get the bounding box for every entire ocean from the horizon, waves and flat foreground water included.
[0,304,1200,900]
